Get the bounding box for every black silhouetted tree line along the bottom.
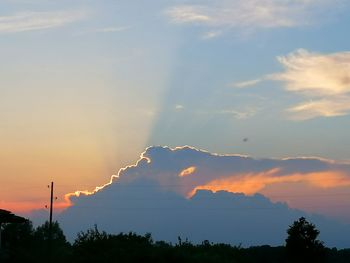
[0,217,350,263]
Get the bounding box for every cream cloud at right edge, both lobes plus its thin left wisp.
[234,49,350,120]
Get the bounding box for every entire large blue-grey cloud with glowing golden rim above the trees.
[59,146,350,247]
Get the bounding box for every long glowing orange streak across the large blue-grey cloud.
[188,168,350,197]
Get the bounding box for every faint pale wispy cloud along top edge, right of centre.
[165,0,343,34]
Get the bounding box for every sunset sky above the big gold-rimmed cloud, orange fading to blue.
[0,0,350,240]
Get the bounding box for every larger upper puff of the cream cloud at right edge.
[270,49,350,97]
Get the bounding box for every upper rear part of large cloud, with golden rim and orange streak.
[65,146,350,205]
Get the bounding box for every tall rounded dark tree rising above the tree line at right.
[286,217,326,262]
